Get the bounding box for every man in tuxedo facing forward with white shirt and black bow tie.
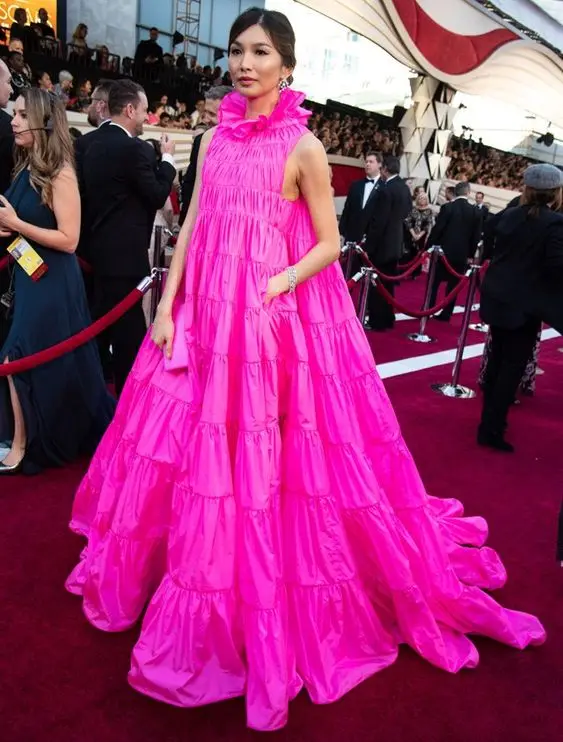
[338,152,383,242]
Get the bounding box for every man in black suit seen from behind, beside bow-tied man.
[366,155,412,331]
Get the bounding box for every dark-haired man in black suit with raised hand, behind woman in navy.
[81,80,176,394]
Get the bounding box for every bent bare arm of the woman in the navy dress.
[0,166,80,253]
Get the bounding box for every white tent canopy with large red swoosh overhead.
[299,0,563,126]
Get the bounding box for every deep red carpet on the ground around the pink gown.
[0,306,563,742]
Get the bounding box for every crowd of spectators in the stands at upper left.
[0,8,225,129]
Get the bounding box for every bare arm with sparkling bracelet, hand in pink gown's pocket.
[265,134,340,303]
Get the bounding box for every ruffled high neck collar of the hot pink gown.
[219,88,311,139]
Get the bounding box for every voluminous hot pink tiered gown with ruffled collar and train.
[67,90,544,730]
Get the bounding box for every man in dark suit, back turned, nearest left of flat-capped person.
[428,182,482,322]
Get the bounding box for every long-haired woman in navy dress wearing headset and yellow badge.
[0,89,114,474]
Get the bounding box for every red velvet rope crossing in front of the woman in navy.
[0,288,144,377]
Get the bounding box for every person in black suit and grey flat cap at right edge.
[477,164,563,452]
